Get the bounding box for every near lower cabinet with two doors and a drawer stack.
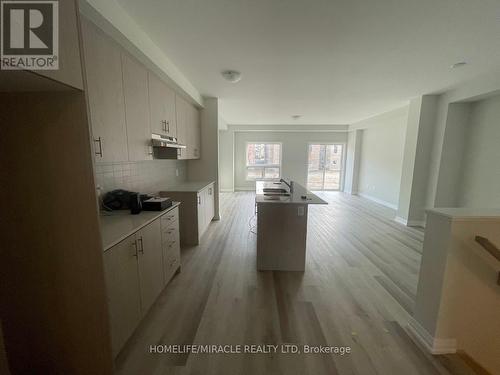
[104,207,181,356]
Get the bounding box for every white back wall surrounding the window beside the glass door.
[234,131,347,190]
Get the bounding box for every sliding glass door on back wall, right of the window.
[307,144,343,190]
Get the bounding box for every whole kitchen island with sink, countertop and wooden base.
[255,181,328,271]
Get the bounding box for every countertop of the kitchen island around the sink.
[255,181,328,204]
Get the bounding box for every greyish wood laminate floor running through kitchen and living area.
[116,193,478,375]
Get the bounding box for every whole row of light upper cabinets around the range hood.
[82,17,201,162]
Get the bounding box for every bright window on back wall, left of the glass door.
[246,143,281,180]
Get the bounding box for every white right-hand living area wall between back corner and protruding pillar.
[352,106,408,209]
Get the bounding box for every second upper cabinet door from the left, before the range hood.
[122,52,153,161]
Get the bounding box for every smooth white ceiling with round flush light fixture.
[114,0,500,124]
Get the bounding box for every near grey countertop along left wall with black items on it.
[100,202,180,251]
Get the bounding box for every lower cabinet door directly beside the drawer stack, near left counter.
[136,219,163,315]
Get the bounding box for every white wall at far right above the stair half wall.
[458,95,500,207]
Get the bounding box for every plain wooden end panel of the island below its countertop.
[257,203,307,271]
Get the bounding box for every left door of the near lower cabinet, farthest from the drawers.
[104,236,141,356]
